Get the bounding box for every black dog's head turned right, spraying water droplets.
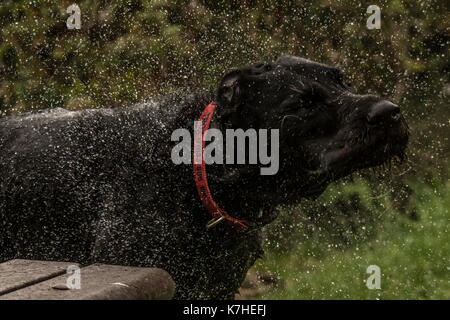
[217,56,408,200]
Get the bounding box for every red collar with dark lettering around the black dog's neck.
[192,101,248,231]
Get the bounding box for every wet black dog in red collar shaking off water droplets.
[0,56,408,299]
